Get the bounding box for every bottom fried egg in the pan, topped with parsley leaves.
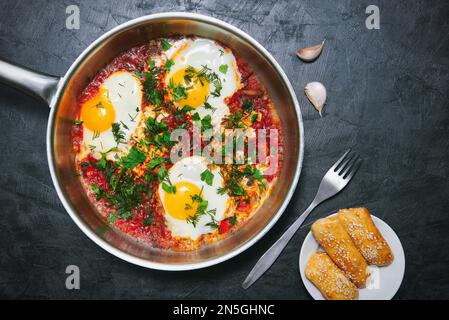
[158,156,229,240]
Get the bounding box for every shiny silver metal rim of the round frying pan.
[47,12,304,271]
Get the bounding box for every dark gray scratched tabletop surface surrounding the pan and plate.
[0,0,449,299]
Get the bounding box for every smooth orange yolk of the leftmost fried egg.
[80,88,115,133]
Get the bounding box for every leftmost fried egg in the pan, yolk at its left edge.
[80,71,142,159]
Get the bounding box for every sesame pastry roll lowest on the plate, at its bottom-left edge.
[305,252,359,300]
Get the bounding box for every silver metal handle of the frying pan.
[0,59,61,106]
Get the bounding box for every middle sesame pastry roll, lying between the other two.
[312,216,368,288]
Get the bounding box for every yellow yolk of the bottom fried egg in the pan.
[164,181,201,220]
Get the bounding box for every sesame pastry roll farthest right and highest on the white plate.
[337,208,394,266]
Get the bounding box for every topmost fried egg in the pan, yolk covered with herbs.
[165,39,242,126]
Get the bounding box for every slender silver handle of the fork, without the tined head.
[242,200,319,289]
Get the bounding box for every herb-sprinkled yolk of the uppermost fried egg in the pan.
[170,67,210,109]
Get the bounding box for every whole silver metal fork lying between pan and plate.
[242,149,362,289]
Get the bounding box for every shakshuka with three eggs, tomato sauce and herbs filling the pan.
[72,37,282,251]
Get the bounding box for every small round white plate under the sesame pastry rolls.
[299,215,405,300]
